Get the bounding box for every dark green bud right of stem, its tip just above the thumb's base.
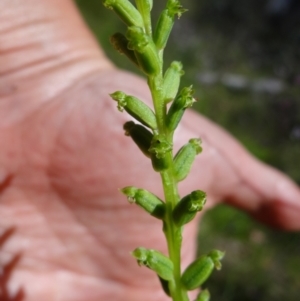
[166,86,195,132]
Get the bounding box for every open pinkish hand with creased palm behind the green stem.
[0,0,300,301]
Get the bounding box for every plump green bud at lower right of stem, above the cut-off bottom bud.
[181,250,224,290]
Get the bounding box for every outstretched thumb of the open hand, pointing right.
[180,113,300,230]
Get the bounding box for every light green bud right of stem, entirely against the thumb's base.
[174,139,202,182]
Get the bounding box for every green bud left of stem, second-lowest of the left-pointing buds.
[121,186,166,219]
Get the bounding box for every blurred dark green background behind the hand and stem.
[76,0,300,301]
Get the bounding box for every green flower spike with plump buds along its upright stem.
[103,0,224,301]
